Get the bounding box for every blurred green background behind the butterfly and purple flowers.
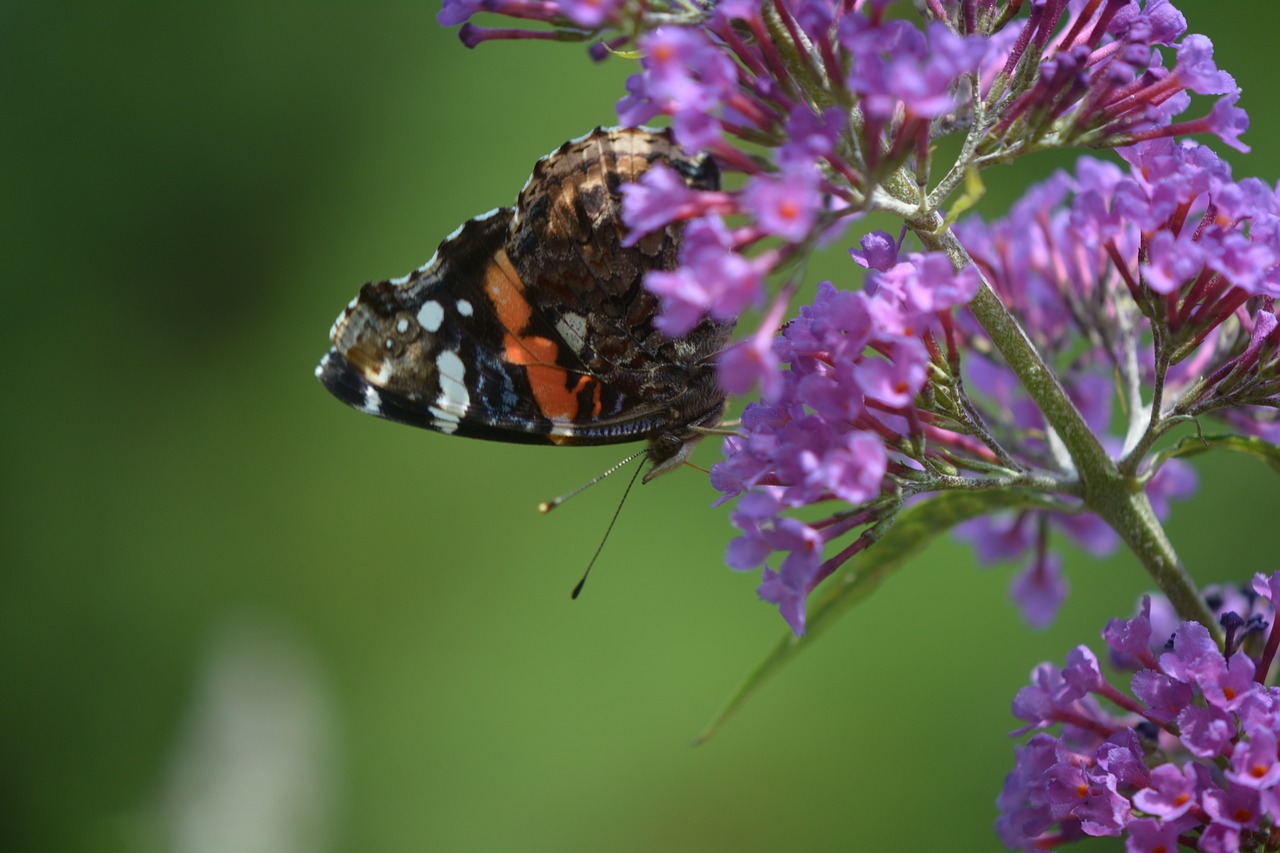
[0,0,1280,853]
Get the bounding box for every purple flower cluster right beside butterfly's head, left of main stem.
[712,255,972,633]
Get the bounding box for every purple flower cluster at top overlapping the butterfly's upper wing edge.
[618,3,987,391]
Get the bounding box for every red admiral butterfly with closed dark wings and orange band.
[316,128,731,482]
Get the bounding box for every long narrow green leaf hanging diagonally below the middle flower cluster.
[694,489,1042,744]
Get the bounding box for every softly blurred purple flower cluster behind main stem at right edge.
[957,141,1280,624]
